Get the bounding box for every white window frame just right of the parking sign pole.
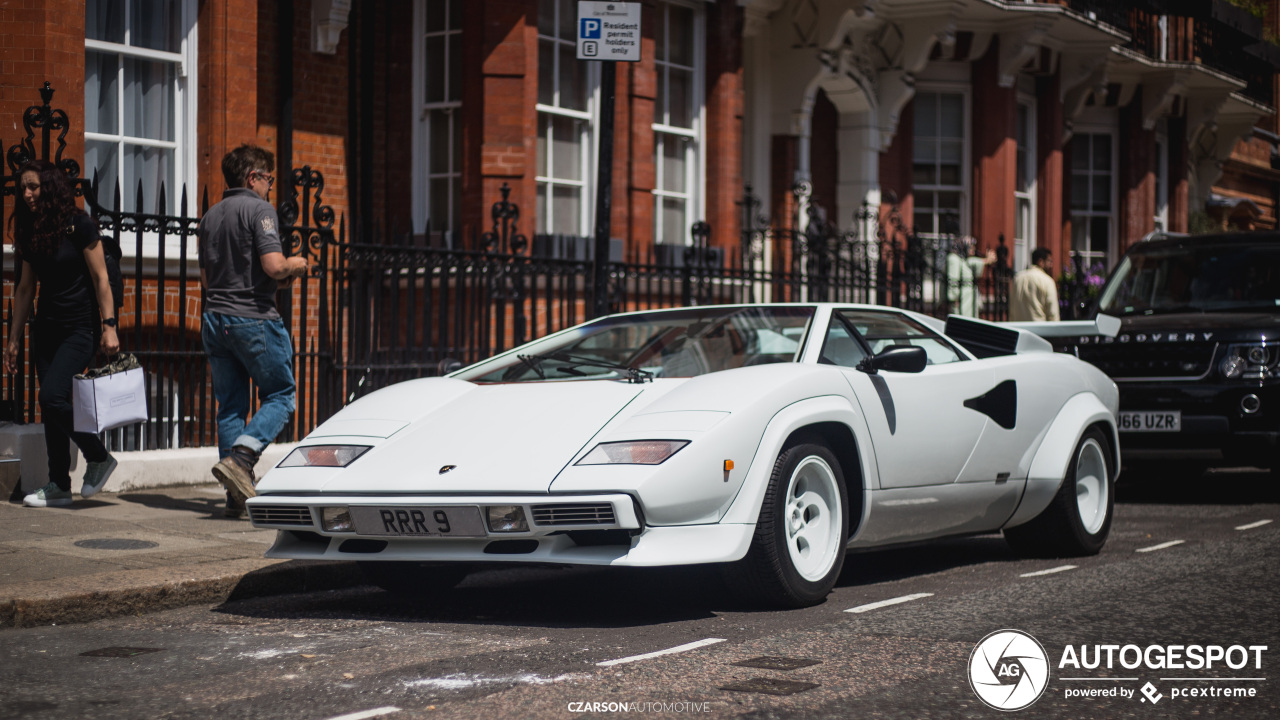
[653,0,707,246]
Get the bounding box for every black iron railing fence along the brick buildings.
[0,88,1010,450]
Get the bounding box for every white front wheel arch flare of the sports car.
[721,395,879,527]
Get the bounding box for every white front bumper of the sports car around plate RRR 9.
[247,493,755,568]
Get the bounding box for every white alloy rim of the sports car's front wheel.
[782,455,844,582]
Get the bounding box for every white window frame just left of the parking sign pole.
[534,0,596,237]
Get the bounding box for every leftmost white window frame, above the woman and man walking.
[82,0,200,219]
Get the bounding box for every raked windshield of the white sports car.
[453,306,814,383]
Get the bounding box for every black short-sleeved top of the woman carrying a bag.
[18,214,97,324]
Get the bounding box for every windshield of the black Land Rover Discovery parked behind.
[1098,238,1280,316]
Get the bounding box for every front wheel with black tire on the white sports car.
[726,443,849,607]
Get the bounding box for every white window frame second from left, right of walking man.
[411,0,465,233]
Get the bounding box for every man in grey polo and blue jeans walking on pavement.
[200,145,308,518]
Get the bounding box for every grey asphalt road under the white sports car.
[0,461,1280,720]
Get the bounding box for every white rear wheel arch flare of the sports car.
[1005,392,1120,528]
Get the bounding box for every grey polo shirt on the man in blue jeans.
[200,187,283,319]
